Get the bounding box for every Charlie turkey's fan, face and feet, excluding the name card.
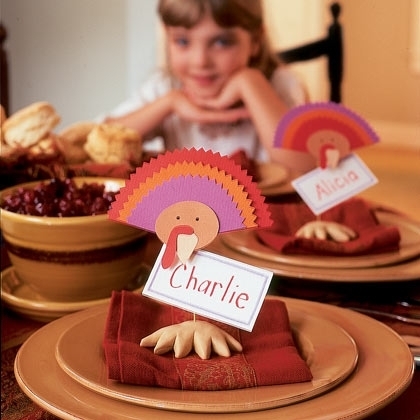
[109,149,272,359]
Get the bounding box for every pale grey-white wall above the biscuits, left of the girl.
[0,0,157,127]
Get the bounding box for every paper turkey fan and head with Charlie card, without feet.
[108,148,273,331]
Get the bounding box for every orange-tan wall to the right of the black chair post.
[342,0,420,124]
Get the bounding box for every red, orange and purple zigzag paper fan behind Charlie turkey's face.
[109,149,272,232]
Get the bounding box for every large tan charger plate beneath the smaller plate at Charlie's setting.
[15,298,414,420]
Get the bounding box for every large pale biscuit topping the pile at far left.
[2,102,60,148]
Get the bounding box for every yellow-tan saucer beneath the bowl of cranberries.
[1,266,150,322]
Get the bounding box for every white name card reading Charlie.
[143,245,273,331]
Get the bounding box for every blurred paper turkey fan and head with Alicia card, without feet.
[274,102,379,215]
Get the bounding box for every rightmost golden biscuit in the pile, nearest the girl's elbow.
[84,124,142,163]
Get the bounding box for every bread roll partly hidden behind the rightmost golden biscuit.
[57,121,96,163]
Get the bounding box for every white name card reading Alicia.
[292,154,378,215]
